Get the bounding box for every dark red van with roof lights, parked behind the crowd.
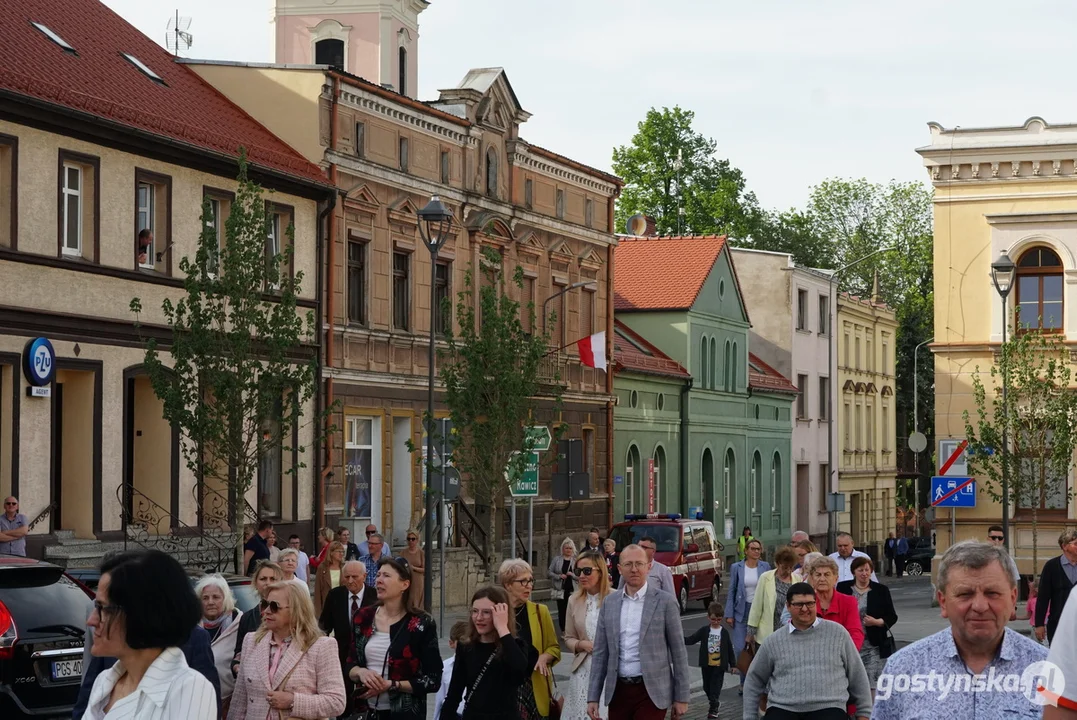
[610,513,725,612]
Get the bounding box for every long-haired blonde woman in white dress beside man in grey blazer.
[561,551,612,720]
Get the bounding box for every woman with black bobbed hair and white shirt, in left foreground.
[83,550,216,720]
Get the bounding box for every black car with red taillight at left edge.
[0,555,94,719]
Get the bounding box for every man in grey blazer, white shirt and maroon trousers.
[587,545,690,720]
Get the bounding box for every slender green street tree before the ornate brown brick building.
[428,248,561,567]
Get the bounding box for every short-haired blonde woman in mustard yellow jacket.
[499,555,560,720]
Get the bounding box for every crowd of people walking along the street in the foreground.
[63,516,1077,720]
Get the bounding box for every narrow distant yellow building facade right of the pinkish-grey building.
[835,294,897,557]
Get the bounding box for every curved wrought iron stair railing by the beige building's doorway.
[116,483,236,573]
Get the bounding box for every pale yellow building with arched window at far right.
[917,117,1077,574]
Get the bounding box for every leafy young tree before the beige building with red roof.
[130,156,318,571]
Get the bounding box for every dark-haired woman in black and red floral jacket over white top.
[346,557,442,720]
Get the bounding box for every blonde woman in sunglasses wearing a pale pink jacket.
[228,582,345,720]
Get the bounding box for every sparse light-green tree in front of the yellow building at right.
[964,333,1077,574]
